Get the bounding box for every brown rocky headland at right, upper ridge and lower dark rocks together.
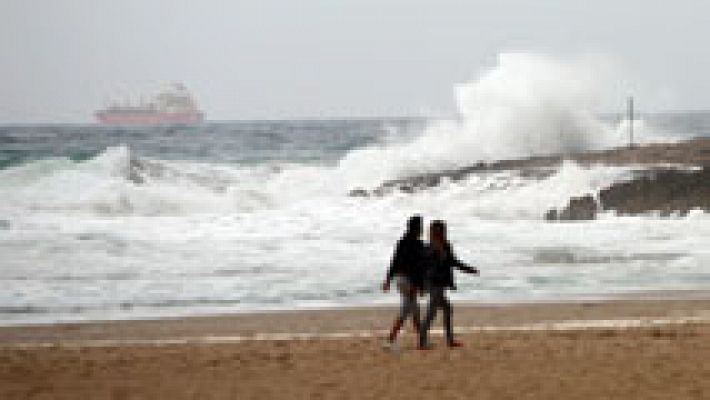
[349,138,710,220]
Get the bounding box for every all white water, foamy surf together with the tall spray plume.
[0,54,710,324]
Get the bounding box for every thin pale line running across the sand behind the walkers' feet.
[0,313,710,350]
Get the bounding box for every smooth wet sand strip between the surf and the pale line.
[0,291,710,347]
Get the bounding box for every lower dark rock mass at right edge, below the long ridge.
[545,167,710,221]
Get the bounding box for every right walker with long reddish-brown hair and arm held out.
[419,220,478,349]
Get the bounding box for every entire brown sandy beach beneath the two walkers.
[0,298,710,399]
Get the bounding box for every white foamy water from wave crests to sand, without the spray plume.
[0,149,710,324]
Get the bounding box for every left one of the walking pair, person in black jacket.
[382,215,425,344]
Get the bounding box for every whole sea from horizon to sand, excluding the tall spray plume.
[0,113,710,325]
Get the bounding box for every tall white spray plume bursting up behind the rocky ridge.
[340,53,618,186]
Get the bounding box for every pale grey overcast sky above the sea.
[0,0,710,123]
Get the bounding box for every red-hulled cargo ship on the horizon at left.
[94,83,204,125]
